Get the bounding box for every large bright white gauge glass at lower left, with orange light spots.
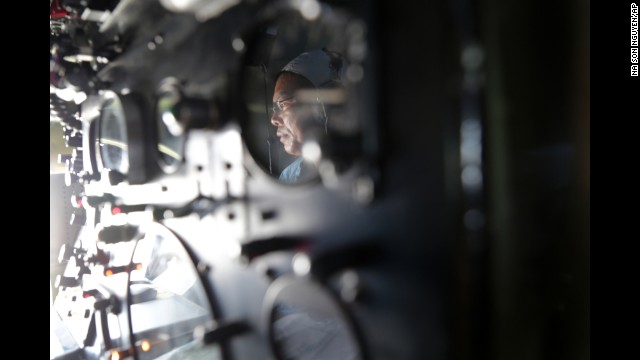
[129,227,220,359]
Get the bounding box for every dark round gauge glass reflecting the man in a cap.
[243,8,365,184]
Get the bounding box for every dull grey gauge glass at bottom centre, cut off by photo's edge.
[271,282,362,360]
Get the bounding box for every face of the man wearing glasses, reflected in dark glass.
[271,74,304,156]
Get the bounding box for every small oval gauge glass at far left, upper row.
[98,94,129,174]
